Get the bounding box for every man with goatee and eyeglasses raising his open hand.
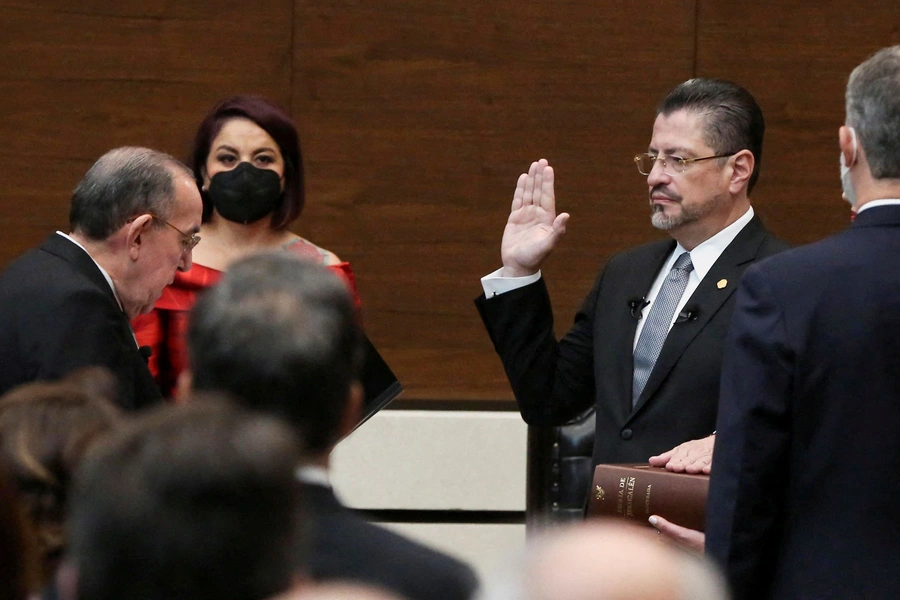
[476,79,787,547]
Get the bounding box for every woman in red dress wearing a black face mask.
[133,96,399,408]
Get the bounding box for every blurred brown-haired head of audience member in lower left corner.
[0,372,122,585]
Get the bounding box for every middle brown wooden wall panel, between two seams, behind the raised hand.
[293,0,694,399]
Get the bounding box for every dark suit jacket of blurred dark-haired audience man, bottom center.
[302,483,477,600]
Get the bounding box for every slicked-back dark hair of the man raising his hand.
[656,78,766,195]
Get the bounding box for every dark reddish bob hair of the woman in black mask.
[189,96,305,229]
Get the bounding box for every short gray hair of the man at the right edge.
[846,46,900,179]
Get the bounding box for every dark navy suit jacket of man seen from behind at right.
[706,206,900,600]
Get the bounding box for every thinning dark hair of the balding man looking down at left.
[69,147,190,240]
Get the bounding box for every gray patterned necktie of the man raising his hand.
[631,252,694,406]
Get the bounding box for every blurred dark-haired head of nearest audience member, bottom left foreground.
[60,399,302,600]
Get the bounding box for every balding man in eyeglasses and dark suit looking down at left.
[0,148,202,409]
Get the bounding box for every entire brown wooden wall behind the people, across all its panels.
[0,0,900,400]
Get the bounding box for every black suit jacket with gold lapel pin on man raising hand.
[475,217,787,464]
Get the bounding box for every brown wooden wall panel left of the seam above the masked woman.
[0,0,293,264]
